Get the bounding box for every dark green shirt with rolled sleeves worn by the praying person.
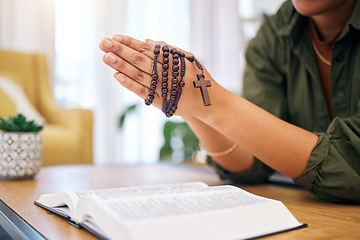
[210,1,360,203]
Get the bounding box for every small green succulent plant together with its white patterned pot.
[0,114,43,180]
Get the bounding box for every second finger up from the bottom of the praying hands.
[103,52,152,86]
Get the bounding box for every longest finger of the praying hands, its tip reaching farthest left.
[99,38,160,74]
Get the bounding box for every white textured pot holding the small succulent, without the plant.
[0,132,42,180]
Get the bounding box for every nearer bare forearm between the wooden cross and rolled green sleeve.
[197,85,318,178]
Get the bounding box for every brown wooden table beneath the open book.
[0,164,360,240]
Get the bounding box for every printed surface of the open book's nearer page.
[86,186,273,221]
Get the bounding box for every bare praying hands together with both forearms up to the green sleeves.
[100,35,318,178]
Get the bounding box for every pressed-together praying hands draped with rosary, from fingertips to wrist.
[100,35,221,117]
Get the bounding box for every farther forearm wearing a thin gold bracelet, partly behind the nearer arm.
[184,117,254,172]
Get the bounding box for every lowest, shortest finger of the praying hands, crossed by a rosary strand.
[114,72,162,108]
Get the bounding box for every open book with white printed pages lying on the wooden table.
[35,182,305,240]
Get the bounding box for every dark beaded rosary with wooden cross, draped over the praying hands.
[145,44,211,117]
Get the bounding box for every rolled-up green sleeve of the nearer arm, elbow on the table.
[294,113,360,203]
